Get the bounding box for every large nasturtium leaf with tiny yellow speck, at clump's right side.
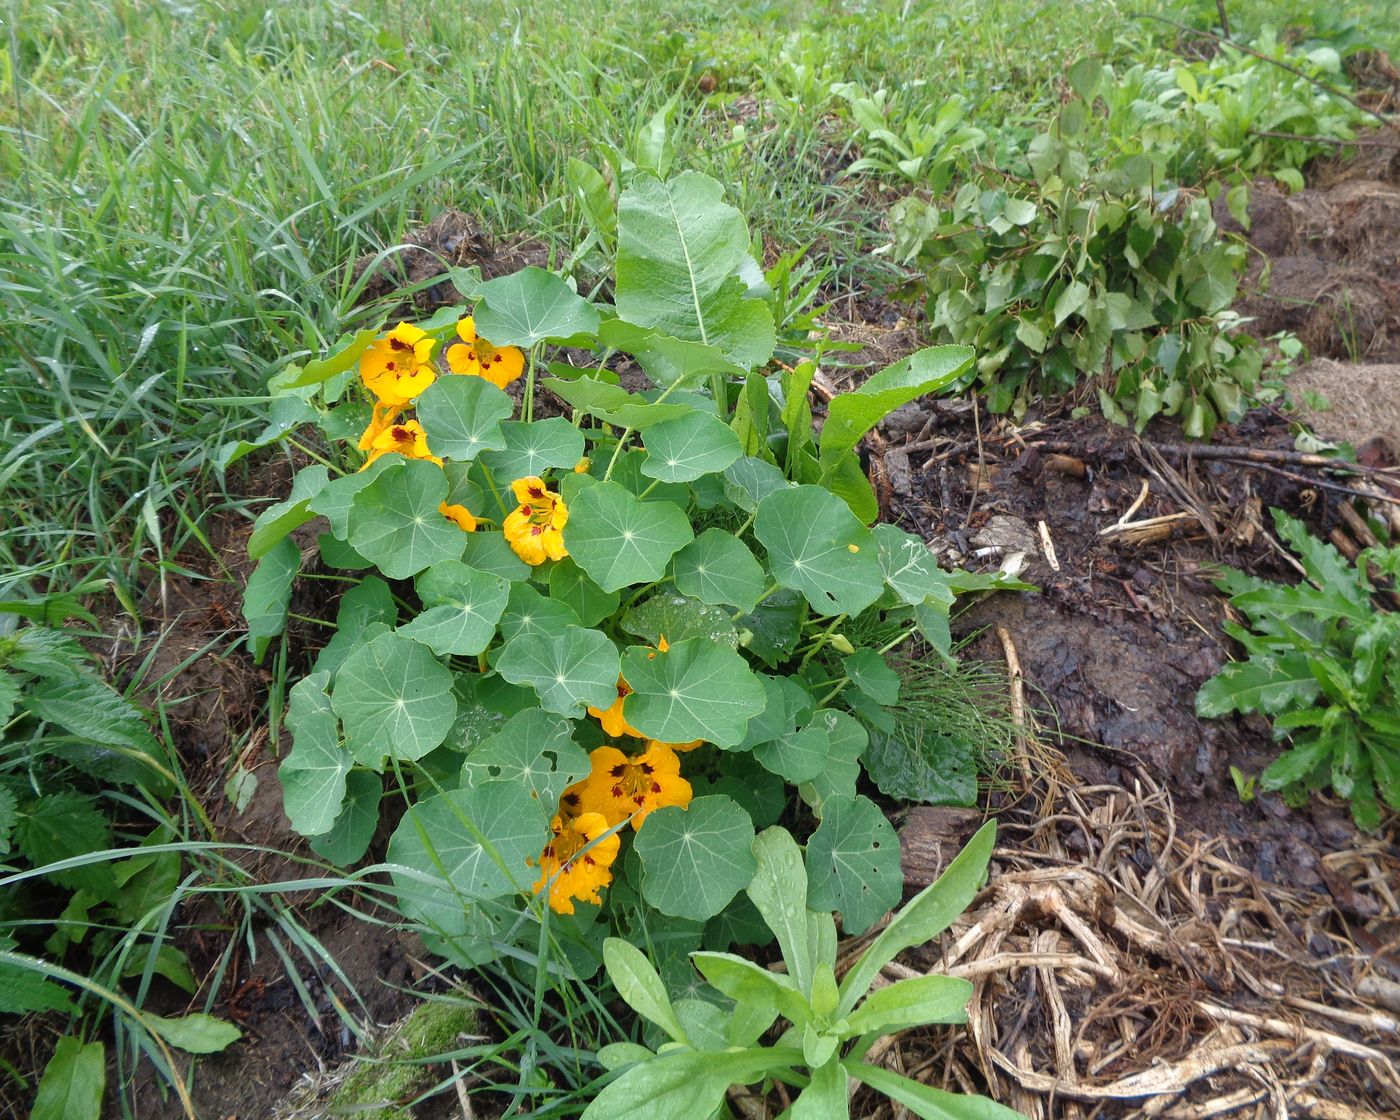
[753,486,883,615]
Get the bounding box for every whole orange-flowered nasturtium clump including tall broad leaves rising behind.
[249,166,981,977]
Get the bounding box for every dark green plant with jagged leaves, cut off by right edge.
[1196,510,1400,829]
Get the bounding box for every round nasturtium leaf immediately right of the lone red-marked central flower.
[564,482,694,591]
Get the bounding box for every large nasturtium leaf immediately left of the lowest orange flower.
[388,781,550,937]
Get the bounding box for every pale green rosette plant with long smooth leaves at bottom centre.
[584,822,1021,1120]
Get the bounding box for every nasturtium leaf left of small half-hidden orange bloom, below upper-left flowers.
[350,459,466,580]
